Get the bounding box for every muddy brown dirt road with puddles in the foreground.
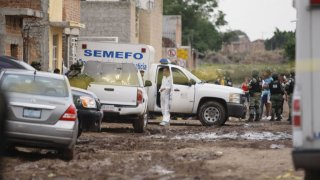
[3,119,303,180]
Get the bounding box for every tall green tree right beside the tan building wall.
[163,0,227,52]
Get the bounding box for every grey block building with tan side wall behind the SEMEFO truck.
[80,0,163,61]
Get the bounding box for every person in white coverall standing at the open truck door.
[159,67,172,126]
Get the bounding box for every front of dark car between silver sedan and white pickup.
[71,87,103,136]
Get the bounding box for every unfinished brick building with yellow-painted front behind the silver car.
[0,0,83,71]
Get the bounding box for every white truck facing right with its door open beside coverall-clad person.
[145,59,246,126]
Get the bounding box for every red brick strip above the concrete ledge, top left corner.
[0,0,41,10]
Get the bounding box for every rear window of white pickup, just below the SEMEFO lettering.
[83,61,140,86]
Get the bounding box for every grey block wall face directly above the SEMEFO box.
[80,1,136,43]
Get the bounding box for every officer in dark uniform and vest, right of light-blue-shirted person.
[269,74,284,121]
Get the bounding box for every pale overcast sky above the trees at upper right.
[219,0,296,41]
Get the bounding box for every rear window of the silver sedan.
[1,74,69,97]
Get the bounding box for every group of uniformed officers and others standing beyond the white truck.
[241,70,294,123]
